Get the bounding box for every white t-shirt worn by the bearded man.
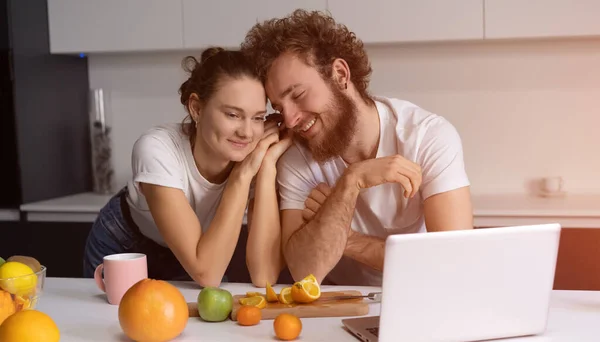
[277,97,469,286]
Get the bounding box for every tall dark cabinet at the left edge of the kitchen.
[0,0,92,209]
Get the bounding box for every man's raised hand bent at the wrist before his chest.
[344,154,423,198]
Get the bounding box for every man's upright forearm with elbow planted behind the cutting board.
[284,177,359,282]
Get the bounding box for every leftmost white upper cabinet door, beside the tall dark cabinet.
[48,0,183,53]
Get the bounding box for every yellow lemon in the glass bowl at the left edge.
[0,261,37,296]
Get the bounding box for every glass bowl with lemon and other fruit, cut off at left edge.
[0,255,42,324]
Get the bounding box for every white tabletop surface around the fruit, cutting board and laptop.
[37,278,600,342]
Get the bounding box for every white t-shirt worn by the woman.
[127,124,250,247]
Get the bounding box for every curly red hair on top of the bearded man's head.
[241,9,372,102]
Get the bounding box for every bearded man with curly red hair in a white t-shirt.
[242,10,473,285]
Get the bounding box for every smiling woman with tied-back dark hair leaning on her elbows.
[84,48,291,287]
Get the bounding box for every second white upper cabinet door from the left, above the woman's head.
[183,0,327,48]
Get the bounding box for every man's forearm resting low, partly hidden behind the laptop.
[344,233,385,271]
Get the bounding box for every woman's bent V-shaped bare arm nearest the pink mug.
[140,173,251,286]
